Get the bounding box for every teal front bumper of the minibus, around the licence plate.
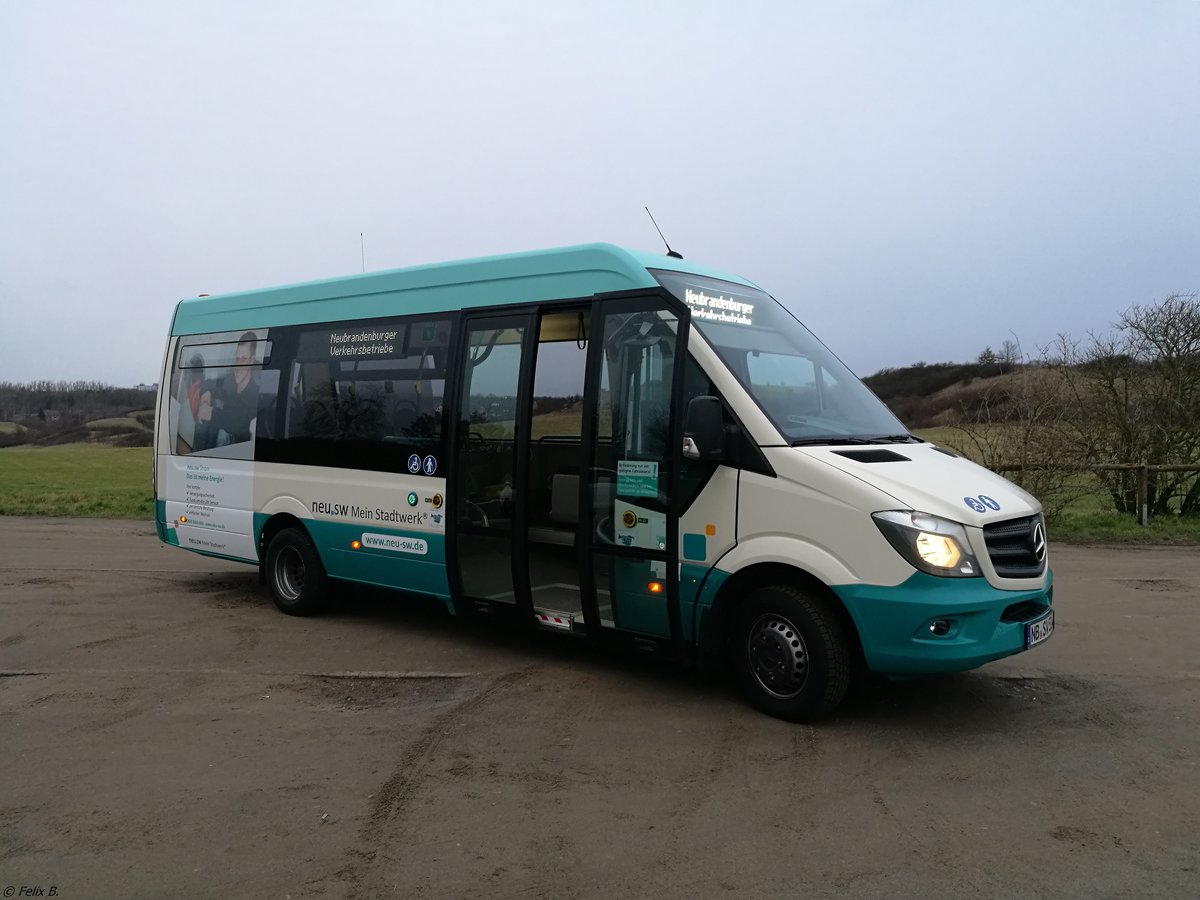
[833,570,1054,674]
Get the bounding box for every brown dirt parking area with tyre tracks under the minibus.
[0,518,1200,899]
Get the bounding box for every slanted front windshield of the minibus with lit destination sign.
[652,270,917,446]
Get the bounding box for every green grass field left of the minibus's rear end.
[0,444,154,518]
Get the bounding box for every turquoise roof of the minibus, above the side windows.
[170,244,754,335]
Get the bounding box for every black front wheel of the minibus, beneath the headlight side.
[731,584,854,722]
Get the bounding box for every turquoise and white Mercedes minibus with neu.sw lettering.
[155,244,1054,720]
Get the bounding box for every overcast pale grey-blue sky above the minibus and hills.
[0,0,1200,385]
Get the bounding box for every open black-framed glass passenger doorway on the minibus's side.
[451,296,686,657]
